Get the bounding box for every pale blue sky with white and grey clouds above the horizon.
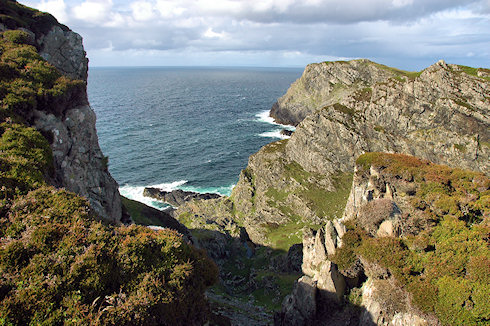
[19,0,490,70]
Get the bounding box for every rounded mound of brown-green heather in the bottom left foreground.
[0,187,217,325]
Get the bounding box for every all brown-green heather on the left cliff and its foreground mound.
[0,8,217,325]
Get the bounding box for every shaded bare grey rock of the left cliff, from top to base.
[0,0,122,222]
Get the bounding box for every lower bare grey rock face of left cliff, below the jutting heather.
[34,105,125,223]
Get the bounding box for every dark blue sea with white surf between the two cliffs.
[88,67,302,208]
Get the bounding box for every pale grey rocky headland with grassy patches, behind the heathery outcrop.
[232,60,490,244]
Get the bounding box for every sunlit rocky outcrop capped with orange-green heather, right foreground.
[276,153,490,325]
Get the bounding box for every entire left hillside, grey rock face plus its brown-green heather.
[0,0,217,325]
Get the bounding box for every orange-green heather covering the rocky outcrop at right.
[333,153,490,325]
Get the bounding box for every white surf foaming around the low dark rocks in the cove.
[119,180,235,211]
